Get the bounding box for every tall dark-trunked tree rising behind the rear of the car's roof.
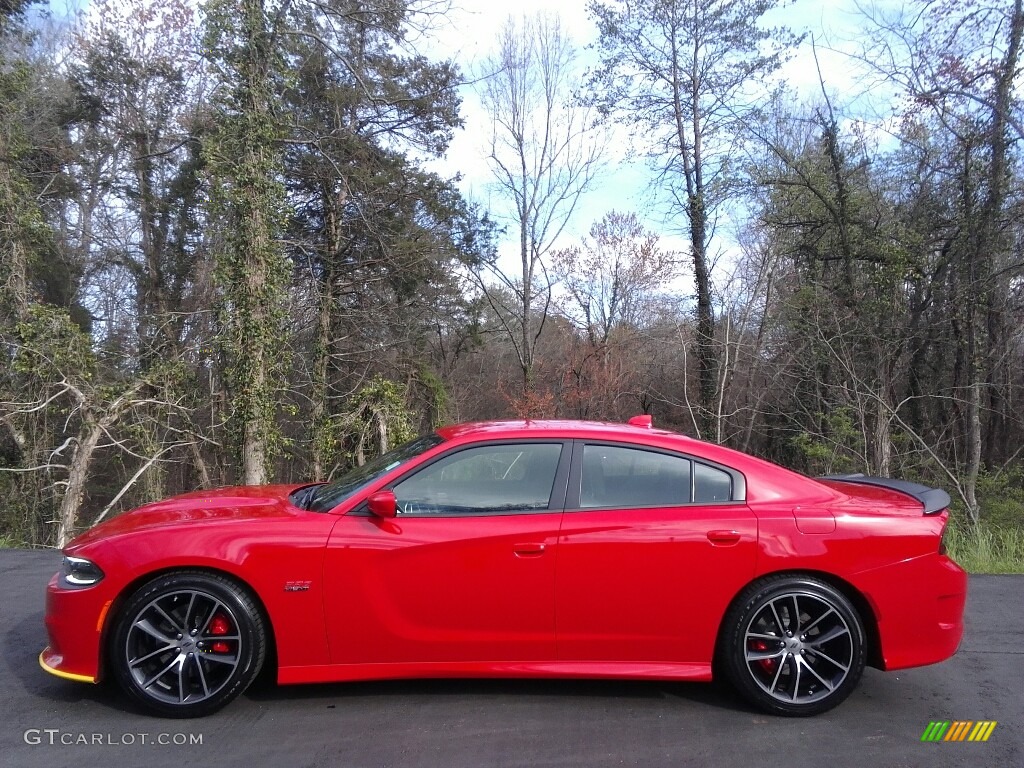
[589,0,796,433]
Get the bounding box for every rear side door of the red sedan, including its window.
[555,441,758,664]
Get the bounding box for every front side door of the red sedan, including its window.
[325,441,569,664]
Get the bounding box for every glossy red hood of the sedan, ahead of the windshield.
[67,483,309,551]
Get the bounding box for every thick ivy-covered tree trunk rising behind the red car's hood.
[205,0,291,484]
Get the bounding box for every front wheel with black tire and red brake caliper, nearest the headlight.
[108,571,267,718]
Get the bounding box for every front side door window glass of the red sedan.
[394,442,562,516]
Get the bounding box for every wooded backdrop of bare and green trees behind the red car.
[0,0,1024,570]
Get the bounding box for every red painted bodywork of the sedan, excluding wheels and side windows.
[40,420,967,716]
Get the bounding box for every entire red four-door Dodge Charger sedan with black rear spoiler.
[40,417,967,717]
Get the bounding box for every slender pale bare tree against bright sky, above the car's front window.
[478,13,603,409]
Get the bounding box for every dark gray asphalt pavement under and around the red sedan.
[0,550,1024,768]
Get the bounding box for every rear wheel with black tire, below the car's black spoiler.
[720,575,865,717]
